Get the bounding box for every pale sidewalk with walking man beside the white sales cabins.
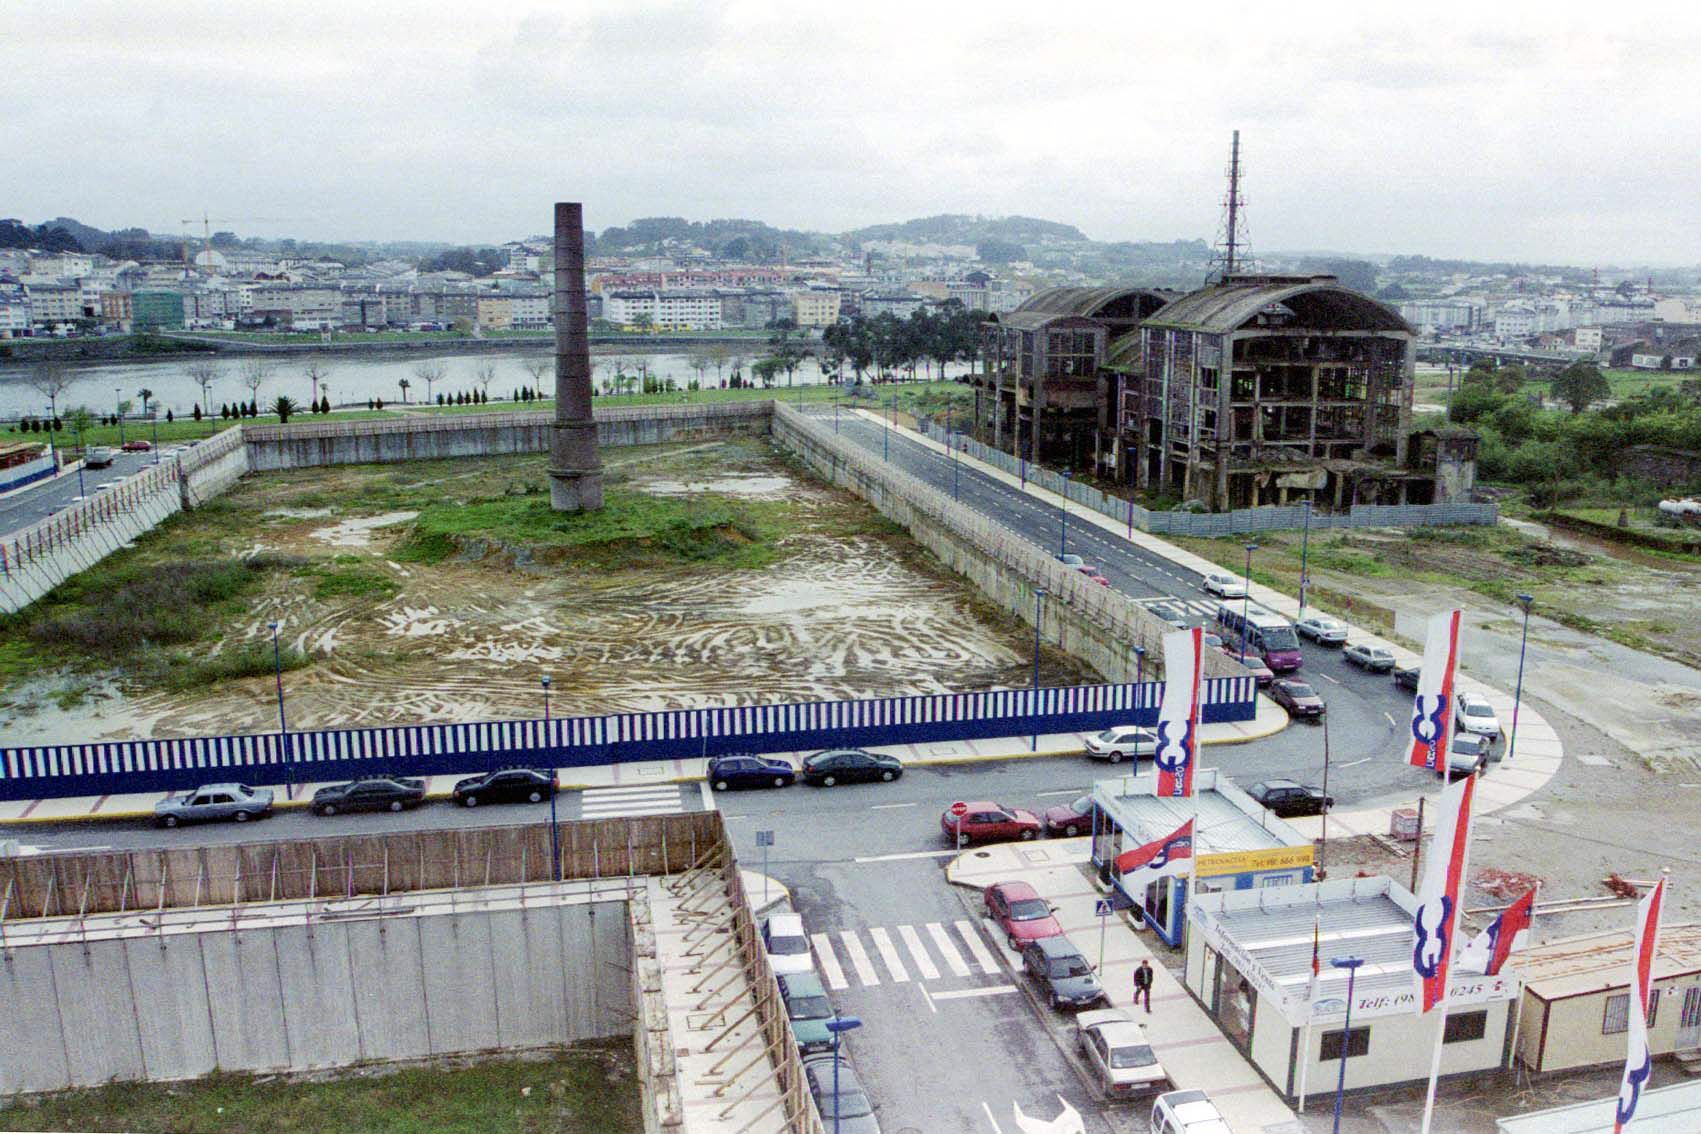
[946,838,1305,1134]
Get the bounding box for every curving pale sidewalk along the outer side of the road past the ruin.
[877,410,1565,838]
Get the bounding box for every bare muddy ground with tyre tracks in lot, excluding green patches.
[0,440,1090,743]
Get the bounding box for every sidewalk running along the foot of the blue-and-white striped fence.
[0,714,1288,826]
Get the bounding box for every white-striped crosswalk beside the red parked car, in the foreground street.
[810,918,1000,989]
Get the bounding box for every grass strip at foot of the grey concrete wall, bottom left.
[0,1042,643,1134]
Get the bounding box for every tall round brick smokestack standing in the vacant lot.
[549,201,602,512]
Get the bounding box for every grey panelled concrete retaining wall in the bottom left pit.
[0,899,631,1093]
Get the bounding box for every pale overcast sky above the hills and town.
[13,0,1701,265]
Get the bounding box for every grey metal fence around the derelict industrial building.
[917,418,1500,537]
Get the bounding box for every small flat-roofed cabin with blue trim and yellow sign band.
[1092,768,1317,947]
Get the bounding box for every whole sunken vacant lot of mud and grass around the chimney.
[0,440,1087,743]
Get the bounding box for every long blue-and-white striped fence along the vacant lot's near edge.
[0,677,1255,799]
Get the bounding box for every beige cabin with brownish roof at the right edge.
[1507,913,1701,1071]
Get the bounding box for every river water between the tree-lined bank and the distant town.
[0,343,968,420]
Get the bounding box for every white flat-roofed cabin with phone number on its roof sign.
[1186,877,1517,1098]
